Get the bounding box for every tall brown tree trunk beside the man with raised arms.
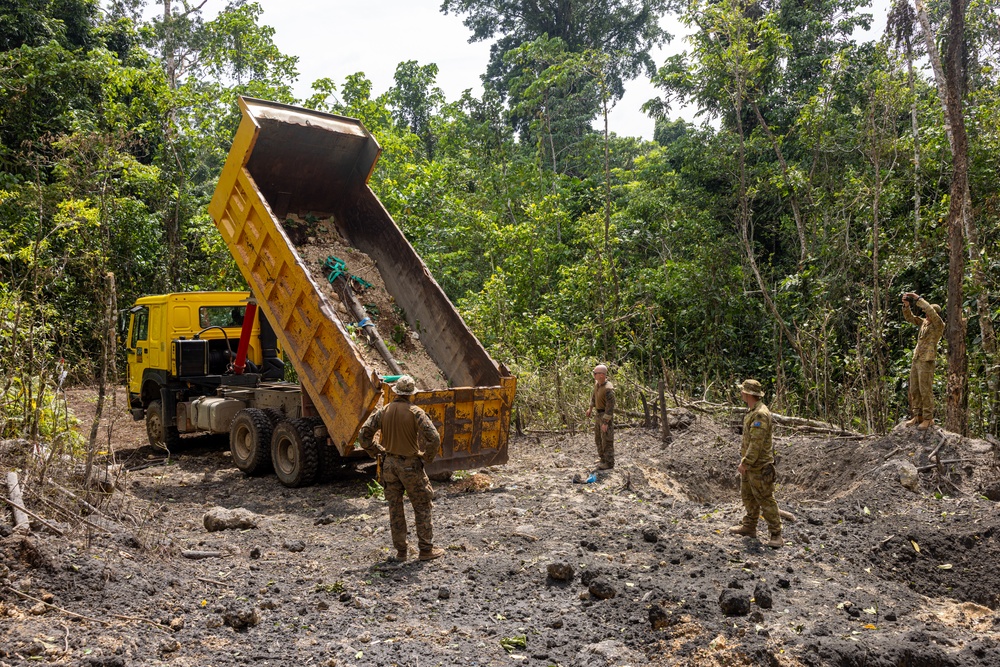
[945,0,969,435]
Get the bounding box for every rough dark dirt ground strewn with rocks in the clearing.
[0,389,1000,667]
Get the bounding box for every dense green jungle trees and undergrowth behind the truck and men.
[0,0,1000,437]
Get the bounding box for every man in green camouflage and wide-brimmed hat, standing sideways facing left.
[729,380,785,549]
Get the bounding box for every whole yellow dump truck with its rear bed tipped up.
[129,98,516,486]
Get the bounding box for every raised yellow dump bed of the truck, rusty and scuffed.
[209,98,517,474]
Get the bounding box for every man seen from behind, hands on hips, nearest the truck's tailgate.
[359,375,444,561]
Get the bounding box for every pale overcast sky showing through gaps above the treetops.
[197,0,888,139]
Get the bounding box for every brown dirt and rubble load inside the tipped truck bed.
[282,215,448,389]
